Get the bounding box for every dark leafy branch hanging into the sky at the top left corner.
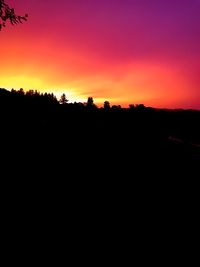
[0,0,28,31]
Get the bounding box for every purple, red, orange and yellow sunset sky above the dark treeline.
[0,0,200,109]
